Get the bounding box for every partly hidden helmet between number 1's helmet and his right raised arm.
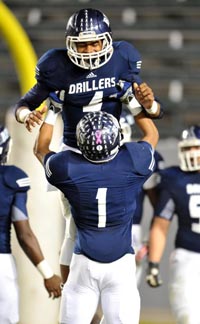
[119,107,135,144]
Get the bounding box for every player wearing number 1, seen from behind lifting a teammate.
[34,111,158,324]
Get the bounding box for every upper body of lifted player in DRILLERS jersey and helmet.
[15,8,163,137]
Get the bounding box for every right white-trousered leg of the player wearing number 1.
[101,254,140,324]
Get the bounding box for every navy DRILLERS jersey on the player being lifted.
[16,41,141,147]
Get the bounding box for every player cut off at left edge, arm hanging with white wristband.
[0,125,61,324]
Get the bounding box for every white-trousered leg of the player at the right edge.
[169,249,200,324]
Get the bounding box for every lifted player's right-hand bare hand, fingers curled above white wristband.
[133,82,155,111]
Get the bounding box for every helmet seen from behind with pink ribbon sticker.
[76,111,121,163]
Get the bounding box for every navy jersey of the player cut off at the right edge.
[155,166,200,252]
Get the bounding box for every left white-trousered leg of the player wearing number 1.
[60,254,100,324]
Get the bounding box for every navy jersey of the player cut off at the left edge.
[0,165,30,253]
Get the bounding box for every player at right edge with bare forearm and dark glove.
[146,125,200,324]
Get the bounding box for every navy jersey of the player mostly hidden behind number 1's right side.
[133,151,164,225]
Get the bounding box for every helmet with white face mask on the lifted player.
[66,8,113,70]
